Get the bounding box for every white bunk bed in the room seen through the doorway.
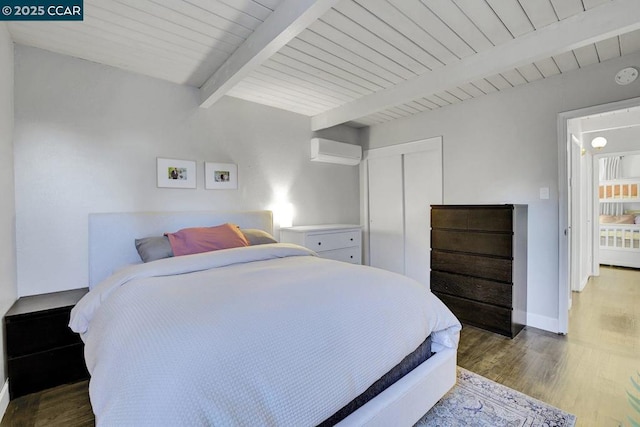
[598,178,640,268]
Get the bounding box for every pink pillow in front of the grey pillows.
[166,223,249,256]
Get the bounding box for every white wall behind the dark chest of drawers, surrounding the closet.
[363,54,640,331]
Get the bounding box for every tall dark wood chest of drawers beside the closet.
[431,205,527,338]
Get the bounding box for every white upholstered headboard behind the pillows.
[89,211,273,288]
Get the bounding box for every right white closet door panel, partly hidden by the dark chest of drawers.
[403,150,442,285]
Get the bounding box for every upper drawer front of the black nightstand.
[5,308,82,358]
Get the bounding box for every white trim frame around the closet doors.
[360,136,444,265]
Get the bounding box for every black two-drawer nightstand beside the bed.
[4,289,89,399]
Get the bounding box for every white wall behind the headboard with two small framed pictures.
[15,46,360,295]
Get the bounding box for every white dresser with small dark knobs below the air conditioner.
[280,224,362,264]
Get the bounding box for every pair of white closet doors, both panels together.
[365,137,443,286]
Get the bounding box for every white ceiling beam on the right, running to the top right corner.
[311,0,640,131]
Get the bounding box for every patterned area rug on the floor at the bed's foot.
[416,367,576,427]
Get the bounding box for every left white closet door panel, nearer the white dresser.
[368,156,404,274]
